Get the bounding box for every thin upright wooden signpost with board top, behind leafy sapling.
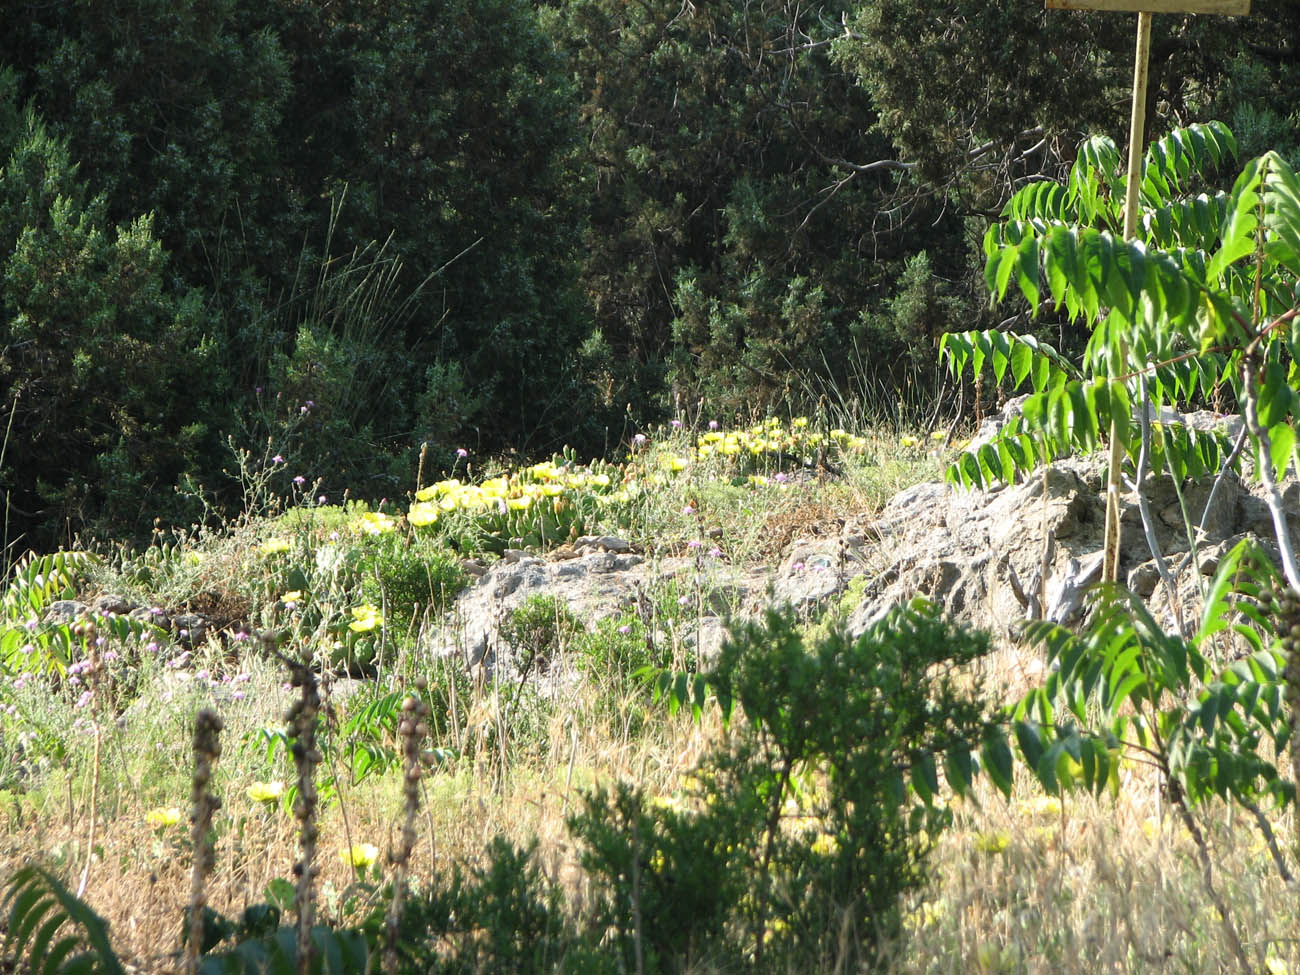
[1045,0,1251,582]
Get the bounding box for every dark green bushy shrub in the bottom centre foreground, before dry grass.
[571,605,992,971]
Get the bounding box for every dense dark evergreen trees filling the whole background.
[0,0,1300,547]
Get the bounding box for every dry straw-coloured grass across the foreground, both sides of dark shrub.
[0,637,1300,975]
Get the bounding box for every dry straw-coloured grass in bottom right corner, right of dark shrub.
[896,774,1300,975]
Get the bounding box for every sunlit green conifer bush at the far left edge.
[0,87,228,546]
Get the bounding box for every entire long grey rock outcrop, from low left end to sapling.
[430,459,1300,666]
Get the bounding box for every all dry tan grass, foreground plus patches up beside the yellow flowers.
[0,421,1300,975]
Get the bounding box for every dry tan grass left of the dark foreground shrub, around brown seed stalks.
[0,667,718,972]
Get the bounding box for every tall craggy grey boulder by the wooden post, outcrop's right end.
[850,460,1300,636]
